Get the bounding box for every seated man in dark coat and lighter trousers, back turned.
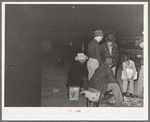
[89,58,123,106]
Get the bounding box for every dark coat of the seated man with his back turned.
[89,64,117,93]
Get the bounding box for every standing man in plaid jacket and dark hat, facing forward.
[100,34,119,75]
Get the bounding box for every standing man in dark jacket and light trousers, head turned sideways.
[87,30,104,80]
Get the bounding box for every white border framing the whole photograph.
[1,2,148,121]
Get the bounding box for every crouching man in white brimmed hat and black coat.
[66,53,88,89]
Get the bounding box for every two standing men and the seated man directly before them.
[87,30,123,106]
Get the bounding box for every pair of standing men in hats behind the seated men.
[87,30,119,79]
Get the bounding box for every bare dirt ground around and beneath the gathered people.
[41,54,143,107]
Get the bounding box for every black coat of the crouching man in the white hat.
[66,61,88,87]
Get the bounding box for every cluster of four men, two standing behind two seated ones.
[66,30,123,106]
